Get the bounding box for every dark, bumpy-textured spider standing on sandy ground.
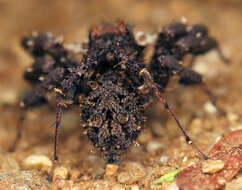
[11,21,227,163]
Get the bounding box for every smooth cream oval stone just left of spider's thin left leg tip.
[23,154,52,171]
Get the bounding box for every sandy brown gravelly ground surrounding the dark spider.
[0,0,242,190]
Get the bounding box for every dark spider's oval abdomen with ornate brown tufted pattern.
[81,73,145,163]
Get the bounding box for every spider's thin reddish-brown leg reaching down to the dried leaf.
[140,68,209,160]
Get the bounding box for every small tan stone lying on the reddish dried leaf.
[202,160,224,174]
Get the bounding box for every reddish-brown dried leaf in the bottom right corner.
[175,130,242,190]
